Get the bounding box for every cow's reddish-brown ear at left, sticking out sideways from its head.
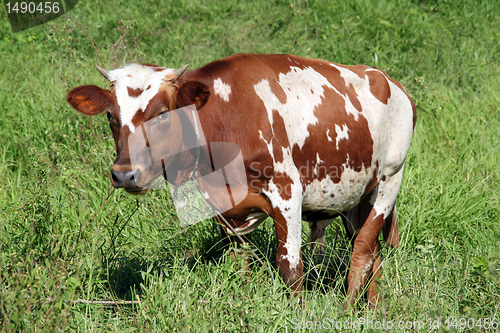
[66,86,111,116]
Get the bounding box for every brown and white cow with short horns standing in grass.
[67,54,416,306]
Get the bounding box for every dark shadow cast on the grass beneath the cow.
[101,218,351,300]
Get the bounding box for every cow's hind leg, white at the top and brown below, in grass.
[343,168,403,308]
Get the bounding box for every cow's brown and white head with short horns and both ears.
[66,64,208,194]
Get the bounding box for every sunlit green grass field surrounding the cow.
[0,0,500,332]
